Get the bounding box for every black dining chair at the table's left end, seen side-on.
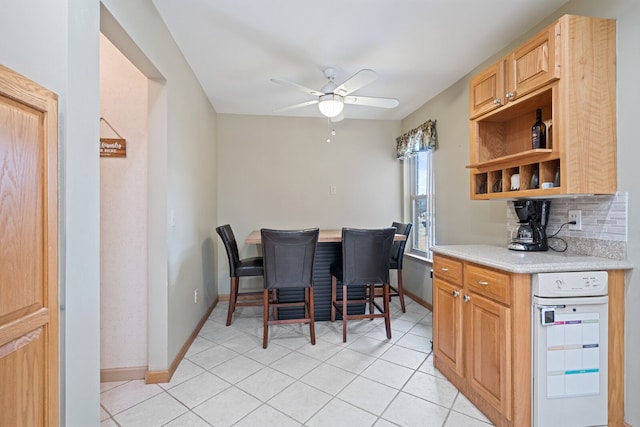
[216,224,264,326]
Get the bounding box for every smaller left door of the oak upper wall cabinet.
[469,60,506,119]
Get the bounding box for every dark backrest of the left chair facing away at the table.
[260,228,320,289]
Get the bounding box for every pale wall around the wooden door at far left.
[0,0,100,426]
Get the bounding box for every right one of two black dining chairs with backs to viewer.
[329,227,396,342]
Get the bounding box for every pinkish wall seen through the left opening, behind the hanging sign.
[100,35,148,372]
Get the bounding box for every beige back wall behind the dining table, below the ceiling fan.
[217,114,402,294]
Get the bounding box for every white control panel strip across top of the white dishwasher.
[531,271,608,298]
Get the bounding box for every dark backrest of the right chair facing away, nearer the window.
[342,227,396,286]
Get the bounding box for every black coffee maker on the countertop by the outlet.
[507,199,551,251]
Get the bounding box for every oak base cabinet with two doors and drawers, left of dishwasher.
[433,255,531,426]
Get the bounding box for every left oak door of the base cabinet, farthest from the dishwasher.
[433,277,463,376]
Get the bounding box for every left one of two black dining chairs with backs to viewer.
[260,228,320,348]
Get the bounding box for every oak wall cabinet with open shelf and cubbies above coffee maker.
[467,15,617,199]
